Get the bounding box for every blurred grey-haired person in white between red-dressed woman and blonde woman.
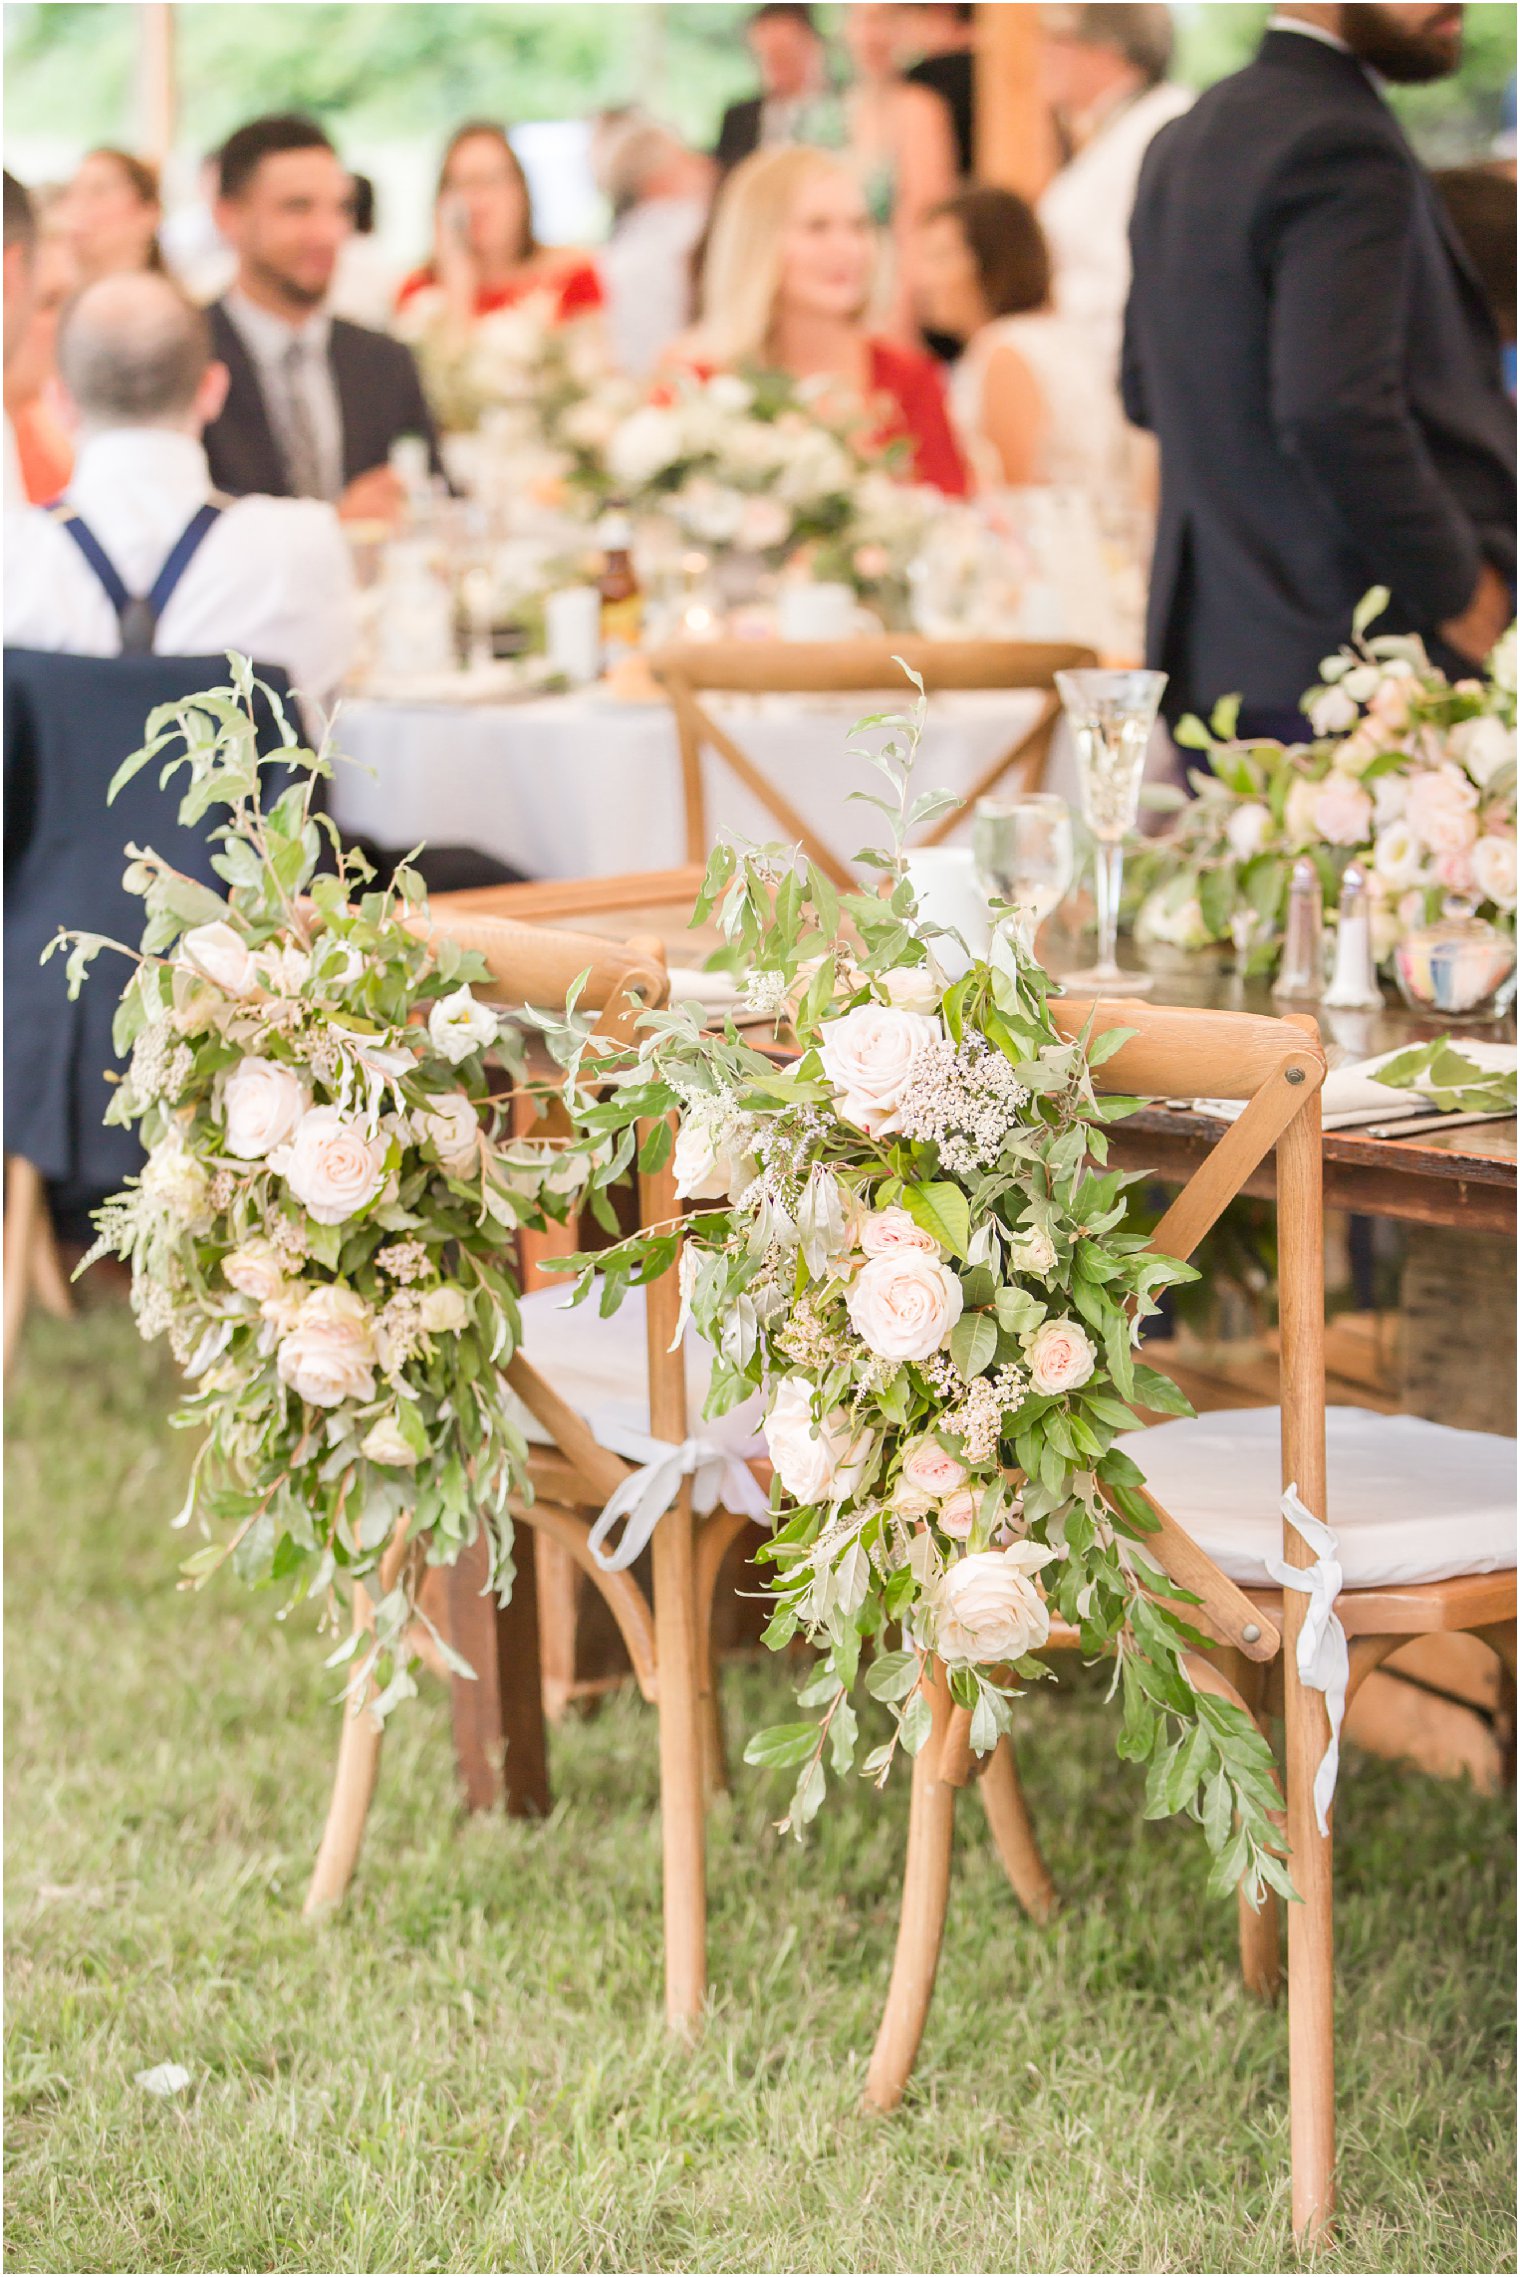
[598,118,712,376]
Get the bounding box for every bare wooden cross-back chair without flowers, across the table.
[649,633,1097,888]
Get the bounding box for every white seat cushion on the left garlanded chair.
[521,1284,765,1455]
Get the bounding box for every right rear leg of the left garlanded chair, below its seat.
[651,1491,708,2038]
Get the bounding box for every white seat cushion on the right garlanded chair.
[1120,1407,1515,1589]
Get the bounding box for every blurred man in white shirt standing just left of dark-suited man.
[1038,0,1192,387]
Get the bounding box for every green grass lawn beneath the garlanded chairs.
[5,1309,1515,2270]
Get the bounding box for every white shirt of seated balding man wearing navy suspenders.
[2,428,355,704]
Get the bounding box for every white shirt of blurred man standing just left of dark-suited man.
[1038,80,1192,394]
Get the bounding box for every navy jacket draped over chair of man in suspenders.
[5,649,289,1209]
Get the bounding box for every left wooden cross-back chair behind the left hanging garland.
[307,904,764,2031]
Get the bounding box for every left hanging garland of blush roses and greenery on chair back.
[48,656,587,1717]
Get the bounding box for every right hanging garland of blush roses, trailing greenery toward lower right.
[552,685,1288,1890]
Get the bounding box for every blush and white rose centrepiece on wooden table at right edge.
[1133,587,1515,970]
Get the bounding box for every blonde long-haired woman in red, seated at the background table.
[676,148,967,496]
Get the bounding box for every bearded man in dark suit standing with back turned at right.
[1124,5,1515,735]
